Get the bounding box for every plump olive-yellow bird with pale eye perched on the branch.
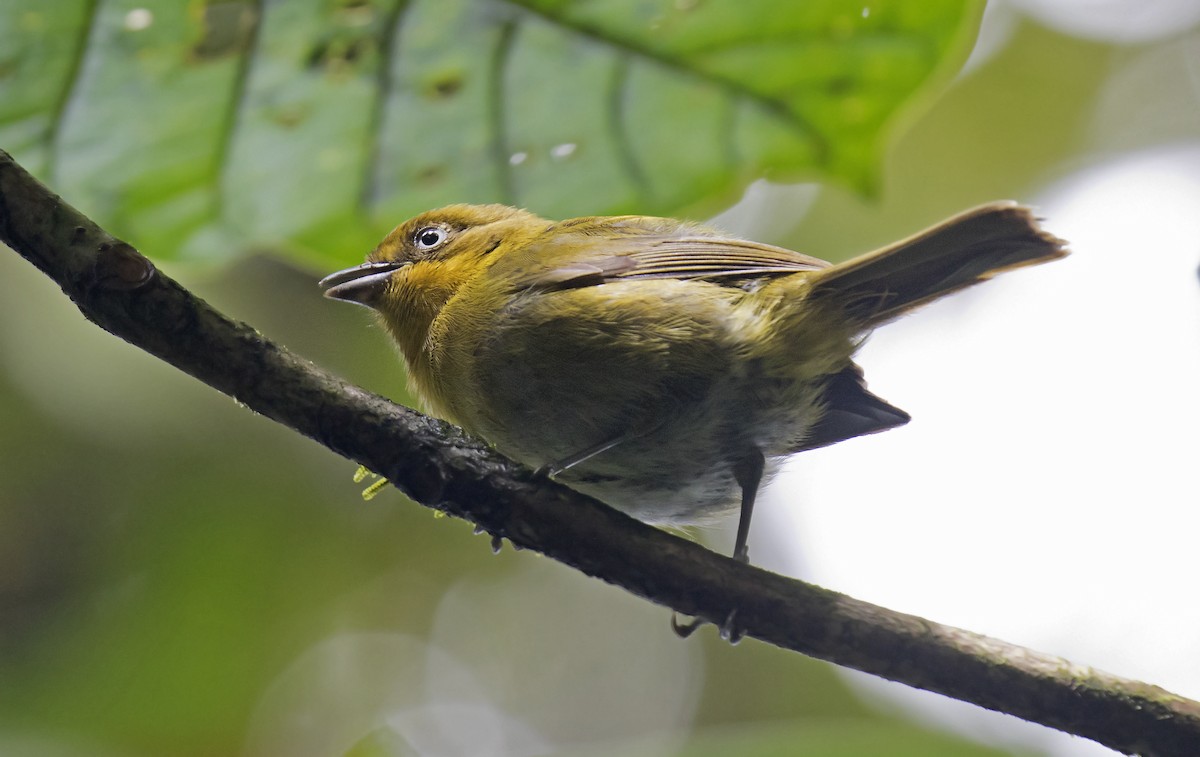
[320,202,1067,561]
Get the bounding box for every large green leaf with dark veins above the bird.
[0,0,979,263]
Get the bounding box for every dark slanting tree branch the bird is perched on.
[0,151,1200,756]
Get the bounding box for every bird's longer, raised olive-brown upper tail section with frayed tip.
[811,203,1067,328]
